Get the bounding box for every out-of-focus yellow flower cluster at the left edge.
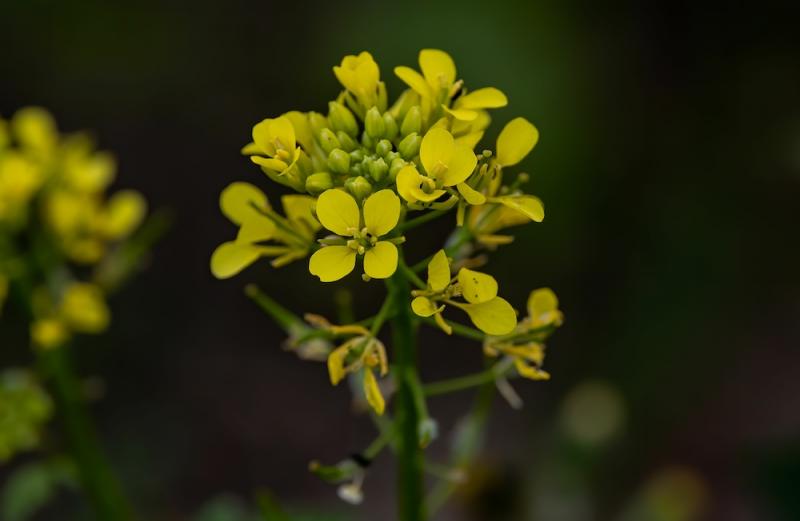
[0,107,147,348]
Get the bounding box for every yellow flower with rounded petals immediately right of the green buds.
[397,127,478,203]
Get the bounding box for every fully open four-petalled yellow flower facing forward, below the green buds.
[308,189,400,282]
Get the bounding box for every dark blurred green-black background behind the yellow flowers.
[0,0,800,521]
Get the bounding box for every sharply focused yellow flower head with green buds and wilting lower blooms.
[211,49,562,500]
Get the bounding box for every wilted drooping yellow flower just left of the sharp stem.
[328,330,389,414]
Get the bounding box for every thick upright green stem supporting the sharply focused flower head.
[387,270,426,521]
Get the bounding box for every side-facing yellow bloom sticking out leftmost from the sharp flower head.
[211,182,320,279]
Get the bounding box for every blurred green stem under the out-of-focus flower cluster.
[39,345,134,521]
